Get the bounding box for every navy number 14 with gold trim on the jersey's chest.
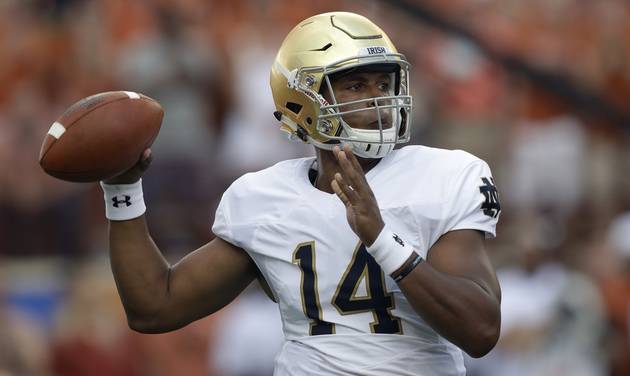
[293,241,402,335]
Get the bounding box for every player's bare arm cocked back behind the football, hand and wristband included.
[101,154,256,333]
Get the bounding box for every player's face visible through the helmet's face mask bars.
[323,72,394,129]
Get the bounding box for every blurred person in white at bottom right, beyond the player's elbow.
[469,212,606,376]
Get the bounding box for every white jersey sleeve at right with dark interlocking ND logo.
[443,159,501,237]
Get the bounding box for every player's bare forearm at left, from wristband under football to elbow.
[109,215,170,325]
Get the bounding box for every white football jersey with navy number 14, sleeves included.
[212,146,499,376]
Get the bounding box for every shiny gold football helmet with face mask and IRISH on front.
[270,12,412,158]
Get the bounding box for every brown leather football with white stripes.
[39,91,164,182]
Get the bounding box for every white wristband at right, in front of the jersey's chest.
[367,225,413,276]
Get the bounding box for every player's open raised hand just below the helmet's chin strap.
[330,144,385,247]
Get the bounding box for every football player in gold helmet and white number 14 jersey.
[102,12,500,375]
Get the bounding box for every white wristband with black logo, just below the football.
[101,179,147,221]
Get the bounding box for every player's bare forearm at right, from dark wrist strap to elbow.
[399,262,501,357]
